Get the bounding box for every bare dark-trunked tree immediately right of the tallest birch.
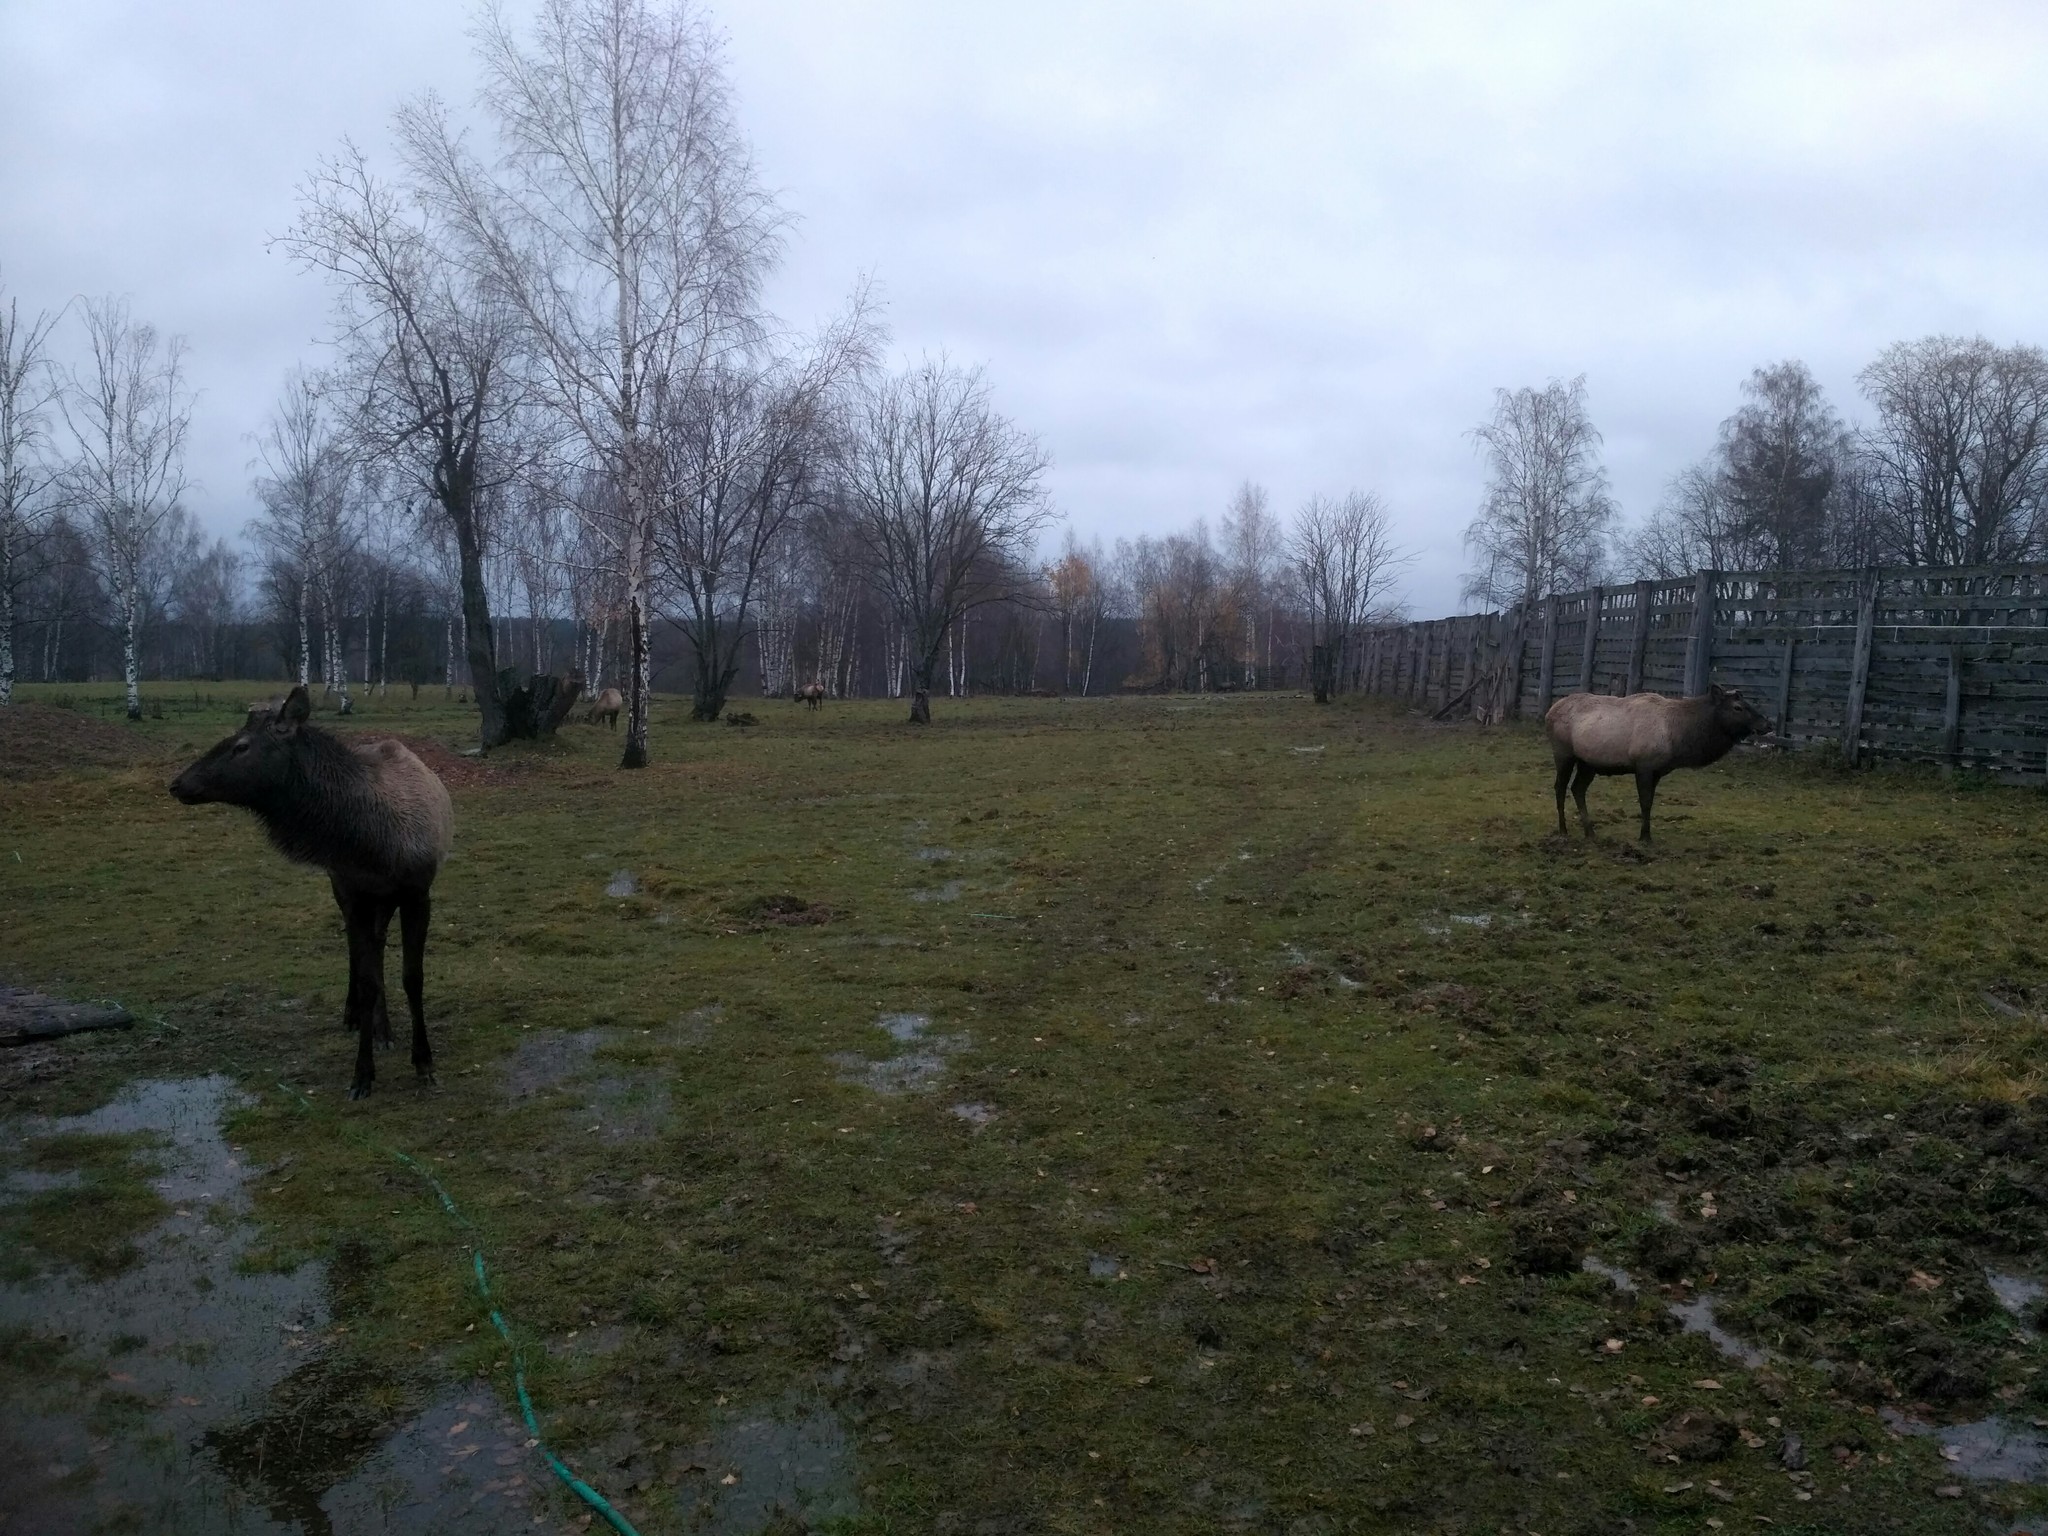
[655,313,870,721]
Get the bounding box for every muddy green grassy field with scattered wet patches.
[0,686,2048,1536]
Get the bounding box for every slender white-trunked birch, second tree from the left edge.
[59,299,193,721]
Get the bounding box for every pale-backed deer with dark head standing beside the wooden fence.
[1544,684,1772,842]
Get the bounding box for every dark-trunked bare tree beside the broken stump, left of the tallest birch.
[281,135,518,748]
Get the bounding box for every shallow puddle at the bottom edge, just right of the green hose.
[678,1411,858,1536]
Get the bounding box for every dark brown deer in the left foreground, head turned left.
[170,688,455,1098]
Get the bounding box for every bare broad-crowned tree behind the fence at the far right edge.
[1860,336,2048,565]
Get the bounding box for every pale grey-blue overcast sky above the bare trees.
[0,0,2048,614]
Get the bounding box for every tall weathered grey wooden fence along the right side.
[1348,565,2048,778]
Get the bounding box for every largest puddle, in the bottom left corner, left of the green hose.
[0,1077,328,1532]
